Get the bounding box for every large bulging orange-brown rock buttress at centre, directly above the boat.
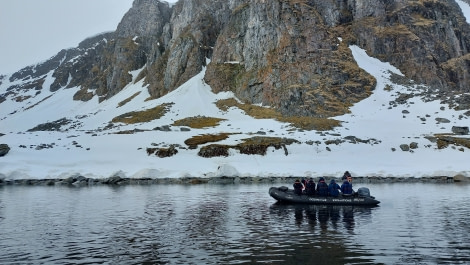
[205,0,375,117]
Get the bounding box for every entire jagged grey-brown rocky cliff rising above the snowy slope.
[0,0,470,117]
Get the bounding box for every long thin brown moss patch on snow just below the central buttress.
[216,98,340,131]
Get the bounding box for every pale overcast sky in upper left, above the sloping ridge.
[0,0,133,74]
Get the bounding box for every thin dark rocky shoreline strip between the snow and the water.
[0,175,470,187]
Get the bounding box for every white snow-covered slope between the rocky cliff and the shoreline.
[0,43,470,179]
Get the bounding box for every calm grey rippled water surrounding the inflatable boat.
[0,183,470,264]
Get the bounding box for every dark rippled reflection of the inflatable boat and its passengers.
[269,202,380,265]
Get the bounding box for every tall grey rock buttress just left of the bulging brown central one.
[142,0,239,97]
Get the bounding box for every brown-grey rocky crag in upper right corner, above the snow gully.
[352,0,470,92]
